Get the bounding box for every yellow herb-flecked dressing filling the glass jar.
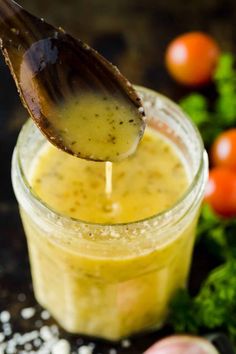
[21,128,195,340]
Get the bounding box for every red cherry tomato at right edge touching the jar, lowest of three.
[205,167,236,217]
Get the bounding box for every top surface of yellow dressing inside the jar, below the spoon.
[32,128,188,223]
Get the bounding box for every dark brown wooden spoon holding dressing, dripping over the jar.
[0,0,145,161]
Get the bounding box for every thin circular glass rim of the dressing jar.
[15,85,207,228]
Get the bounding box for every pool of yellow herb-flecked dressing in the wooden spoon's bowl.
[50,93,144,162]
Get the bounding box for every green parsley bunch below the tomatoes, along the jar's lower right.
[169,205,236,343]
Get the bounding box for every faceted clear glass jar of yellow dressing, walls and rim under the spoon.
[12,87,208,340]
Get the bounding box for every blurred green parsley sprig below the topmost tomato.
[180,53,236,147]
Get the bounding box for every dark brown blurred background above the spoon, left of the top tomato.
[21,0,236,95]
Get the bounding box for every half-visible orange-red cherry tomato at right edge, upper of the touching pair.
[211,128,236,171]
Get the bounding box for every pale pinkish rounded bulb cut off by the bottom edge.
[144,335,219,354]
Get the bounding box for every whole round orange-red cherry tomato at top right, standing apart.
[166,32,220,86]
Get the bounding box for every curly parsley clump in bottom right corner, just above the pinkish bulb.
[169,259,236,342]
